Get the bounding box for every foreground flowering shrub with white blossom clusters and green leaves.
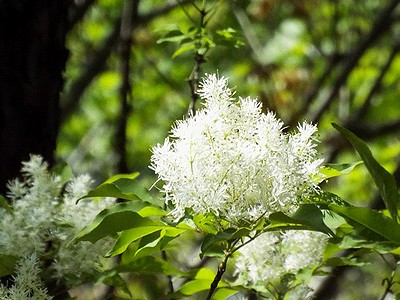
[0,75,400,300]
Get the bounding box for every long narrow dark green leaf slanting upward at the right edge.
[332,123,400,220]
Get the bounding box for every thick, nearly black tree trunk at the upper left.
[0,0,70,193]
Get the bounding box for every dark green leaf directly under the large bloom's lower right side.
[267,204,334,236]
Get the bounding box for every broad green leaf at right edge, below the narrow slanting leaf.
[329,204,400,244]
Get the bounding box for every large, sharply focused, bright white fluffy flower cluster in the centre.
[150,74,322,225]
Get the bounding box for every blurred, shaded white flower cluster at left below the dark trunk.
[0,155,113,286]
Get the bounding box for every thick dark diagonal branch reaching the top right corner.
[311,0,400,123]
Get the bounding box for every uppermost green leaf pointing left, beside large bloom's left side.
[81,172,154,203]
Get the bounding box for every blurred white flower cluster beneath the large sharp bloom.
[235,230,328,299]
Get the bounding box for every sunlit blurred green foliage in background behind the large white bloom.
[56,0,400,299]
